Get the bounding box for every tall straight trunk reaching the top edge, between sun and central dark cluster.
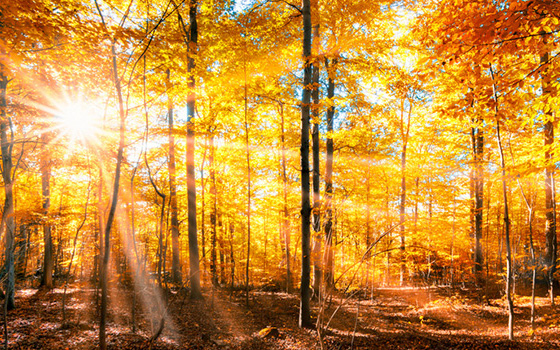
[187,0,202,299]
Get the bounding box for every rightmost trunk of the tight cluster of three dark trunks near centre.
[324,59,337,293]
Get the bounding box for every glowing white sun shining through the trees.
[56,100,101,142]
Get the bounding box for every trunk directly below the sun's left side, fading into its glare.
[41,132,54,289]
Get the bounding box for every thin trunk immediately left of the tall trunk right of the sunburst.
[167,69,182,285]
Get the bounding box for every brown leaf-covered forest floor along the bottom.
[2,288,560,350]
